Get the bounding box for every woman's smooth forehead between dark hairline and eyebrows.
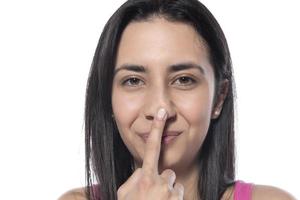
[116,18,209,73]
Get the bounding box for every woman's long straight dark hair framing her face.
[85,0,235,200]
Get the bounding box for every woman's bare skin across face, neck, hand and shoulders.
[60,18,294,200]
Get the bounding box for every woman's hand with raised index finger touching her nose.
[117,109,184,200]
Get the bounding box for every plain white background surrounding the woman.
[0,0,300,200]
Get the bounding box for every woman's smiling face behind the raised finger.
[112,18,219,170]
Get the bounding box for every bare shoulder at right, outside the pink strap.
[252,185,296,200]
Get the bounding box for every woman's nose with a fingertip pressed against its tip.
[144,86,176,120]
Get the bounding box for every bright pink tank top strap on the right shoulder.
[233,181,253,200]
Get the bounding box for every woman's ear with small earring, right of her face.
[211,79,229,119]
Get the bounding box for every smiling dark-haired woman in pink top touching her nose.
[61,0,293,200]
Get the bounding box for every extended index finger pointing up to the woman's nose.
[142,108,167,173]
